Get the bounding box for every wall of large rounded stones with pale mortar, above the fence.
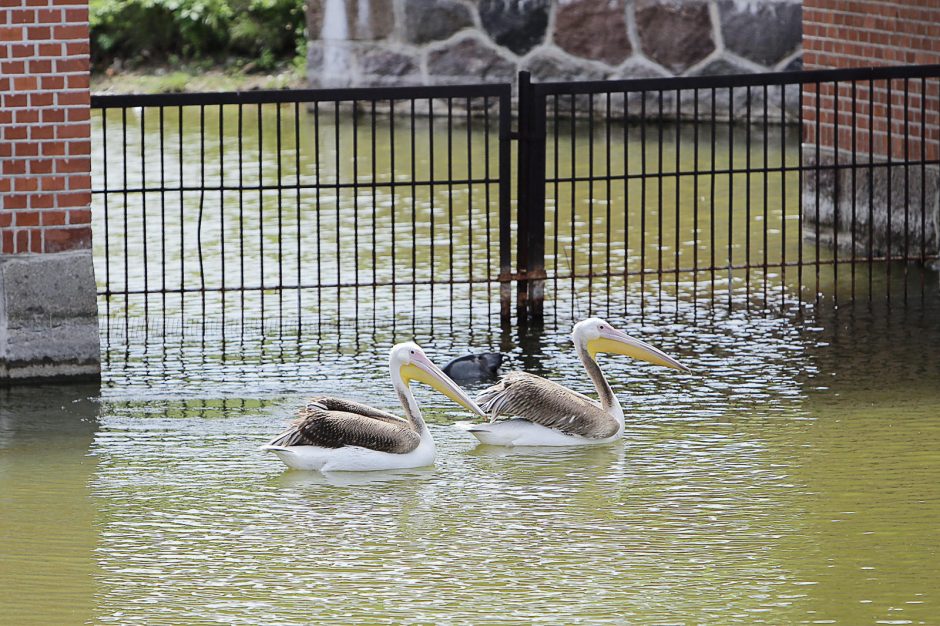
[307,0,801,87]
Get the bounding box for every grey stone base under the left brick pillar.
[0,250,101,385]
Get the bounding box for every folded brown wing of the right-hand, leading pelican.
[476,372,619,439]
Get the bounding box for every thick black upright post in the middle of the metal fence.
[516,72,545,322]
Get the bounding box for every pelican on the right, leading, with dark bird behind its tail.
[467,317,689,446]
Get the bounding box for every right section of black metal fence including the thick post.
[517,66,940,318]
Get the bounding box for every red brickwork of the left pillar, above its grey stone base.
[0,0,91,254]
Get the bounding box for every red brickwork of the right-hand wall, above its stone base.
[803,0,940,159]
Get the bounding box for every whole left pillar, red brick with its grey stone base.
[0,0,100,383]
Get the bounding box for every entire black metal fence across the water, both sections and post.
[92,66,940,320]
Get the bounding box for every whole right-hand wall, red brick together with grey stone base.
[803,0,940,254]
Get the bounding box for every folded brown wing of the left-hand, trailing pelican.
[267,402,421,454]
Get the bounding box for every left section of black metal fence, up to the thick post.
[92,85,510,326]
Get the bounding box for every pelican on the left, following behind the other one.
[261,342,486,472]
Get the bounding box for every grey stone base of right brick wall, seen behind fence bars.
[802,144,940,259]
